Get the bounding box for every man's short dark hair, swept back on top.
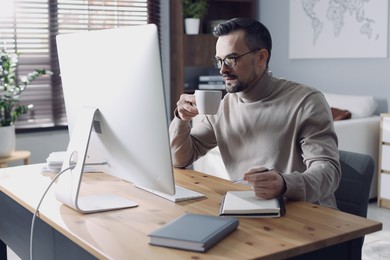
[213,17,272,67]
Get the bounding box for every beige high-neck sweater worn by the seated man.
[169,70,341,208]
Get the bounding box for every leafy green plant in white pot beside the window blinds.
[0,48,51,158]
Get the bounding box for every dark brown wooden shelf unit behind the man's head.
[169,0,256,116]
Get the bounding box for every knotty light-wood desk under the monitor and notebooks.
[0,165,382,259]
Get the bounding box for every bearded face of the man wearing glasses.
[215,30,268,93]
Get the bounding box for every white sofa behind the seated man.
[193,93,380,199]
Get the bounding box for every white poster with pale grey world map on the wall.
[289,0,388,59]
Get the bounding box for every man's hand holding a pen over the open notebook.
[244,167,285,199]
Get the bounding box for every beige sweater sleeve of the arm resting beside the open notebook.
[284,92,341,207]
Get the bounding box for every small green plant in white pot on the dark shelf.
[183,0,208,34]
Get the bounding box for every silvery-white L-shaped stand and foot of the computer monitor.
[56,107,138,213]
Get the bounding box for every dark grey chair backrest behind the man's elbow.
[335,150,375,217]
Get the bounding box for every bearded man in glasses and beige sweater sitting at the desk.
[169,18,341,208]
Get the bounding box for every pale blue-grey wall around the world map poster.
[257,0,390,113]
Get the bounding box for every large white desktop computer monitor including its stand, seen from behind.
[56,24,175,213]
